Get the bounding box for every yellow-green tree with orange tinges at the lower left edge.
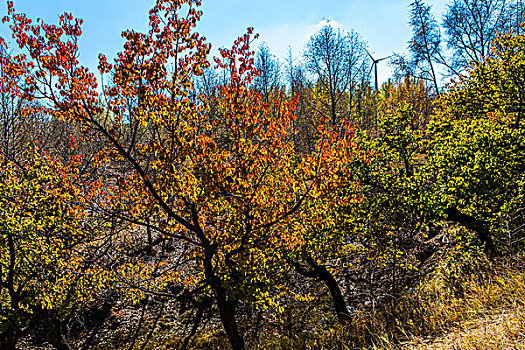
[0,148,102,349]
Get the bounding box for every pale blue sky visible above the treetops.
[0,0,446,85]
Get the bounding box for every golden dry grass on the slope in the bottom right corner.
[239,255,525,350]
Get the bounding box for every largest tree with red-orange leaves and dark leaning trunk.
[0,0,360,349]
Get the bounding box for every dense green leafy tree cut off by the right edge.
[429,28,524,255]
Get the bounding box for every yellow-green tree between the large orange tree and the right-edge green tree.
[340,100,428,306]
